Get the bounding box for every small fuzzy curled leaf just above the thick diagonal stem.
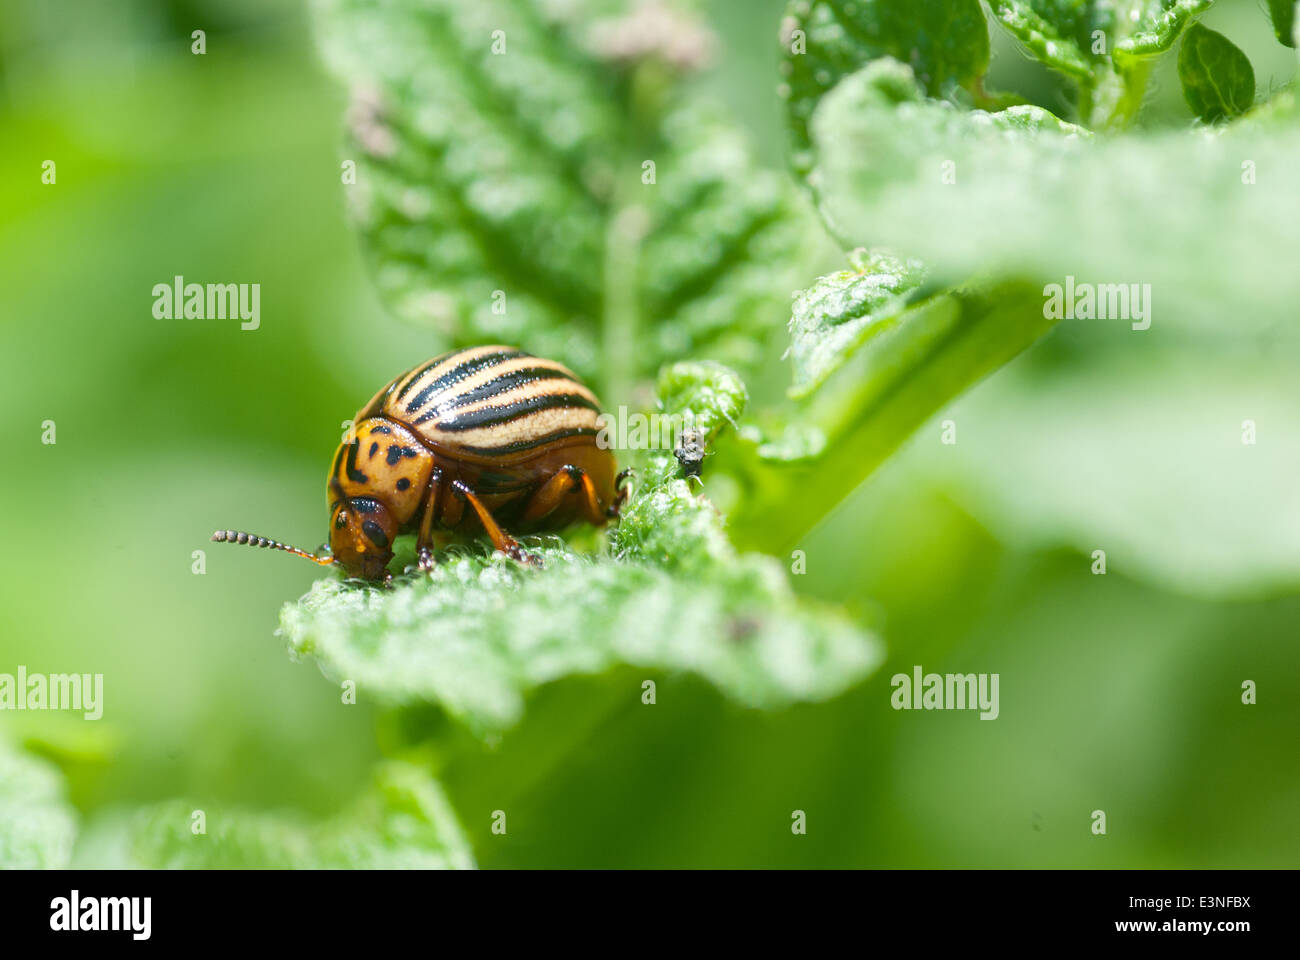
[790,252,924,397]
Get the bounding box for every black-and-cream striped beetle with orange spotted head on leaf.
[212,345,627,581]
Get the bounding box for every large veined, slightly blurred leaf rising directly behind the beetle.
[310,0,806,392]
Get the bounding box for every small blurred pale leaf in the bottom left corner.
[0,739,77,869]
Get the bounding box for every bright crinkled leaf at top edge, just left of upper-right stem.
[989,0,1115,86]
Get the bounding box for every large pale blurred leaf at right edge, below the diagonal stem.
[915,355,1300,598]
